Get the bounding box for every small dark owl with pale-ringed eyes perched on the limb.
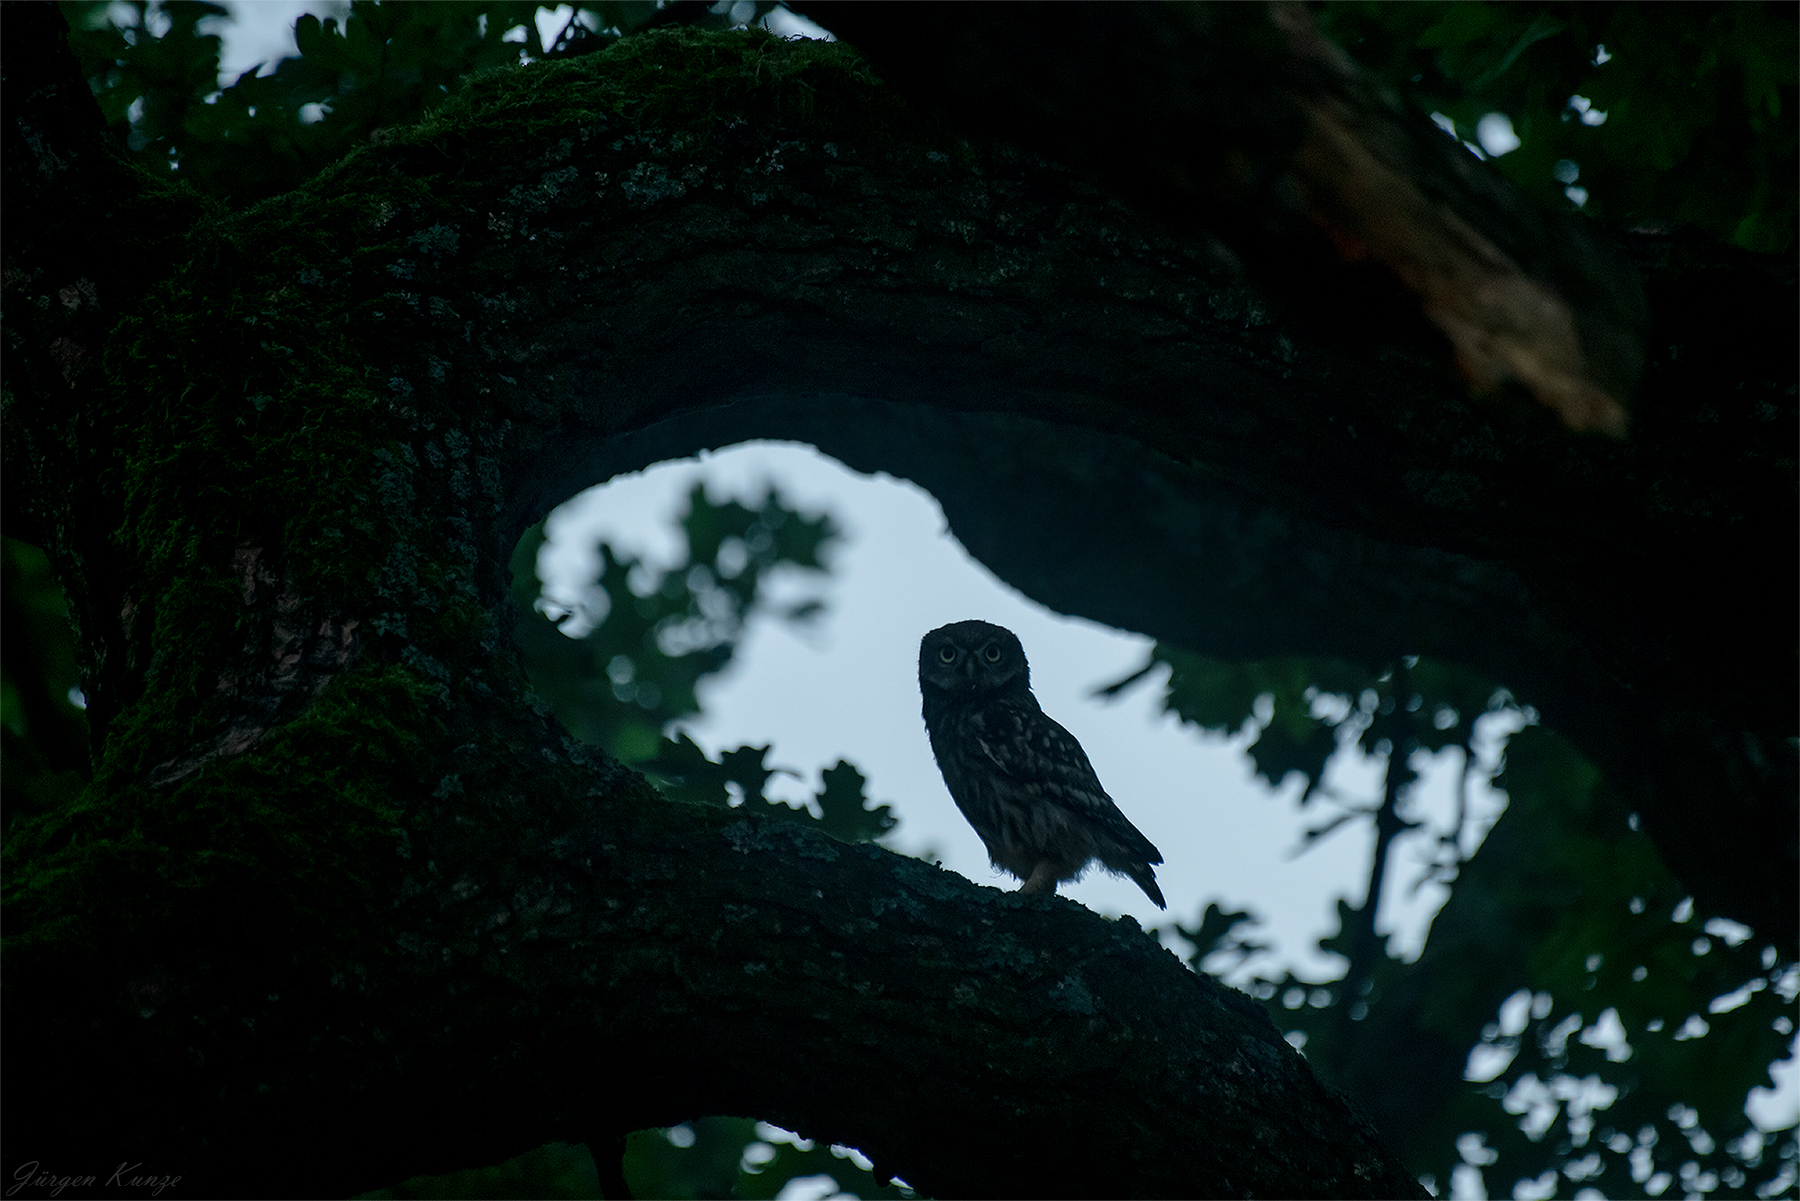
[918,621,1166,909]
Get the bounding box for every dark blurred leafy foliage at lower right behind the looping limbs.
[1103,646,1800,1196]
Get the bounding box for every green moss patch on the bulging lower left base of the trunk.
[5,668,445,960]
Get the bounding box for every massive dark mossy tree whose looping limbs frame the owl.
[5,9,1793,1196]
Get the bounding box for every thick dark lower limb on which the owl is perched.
[9,734,1418,1196]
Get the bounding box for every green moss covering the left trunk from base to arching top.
[5,32,921,979]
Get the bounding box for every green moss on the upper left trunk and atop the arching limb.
[75,31,896,771]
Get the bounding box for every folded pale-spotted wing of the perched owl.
[968,697,1163,862]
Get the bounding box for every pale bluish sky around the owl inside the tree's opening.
[540,443,1501,974]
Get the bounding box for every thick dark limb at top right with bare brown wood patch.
[805,0,1647,438]
